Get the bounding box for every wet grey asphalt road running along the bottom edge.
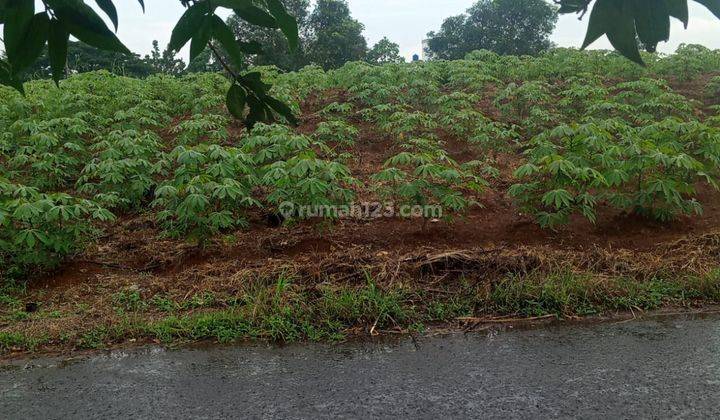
[0,317,720,419]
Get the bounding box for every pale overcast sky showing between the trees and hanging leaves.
[15,0,720,58]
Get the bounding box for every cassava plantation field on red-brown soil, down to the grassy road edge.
[0,46,720,353]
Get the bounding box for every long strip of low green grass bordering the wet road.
[0,270,720,353]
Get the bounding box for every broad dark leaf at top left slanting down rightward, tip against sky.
[47,0,130,54]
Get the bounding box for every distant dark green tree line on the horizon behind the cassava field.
[16,0,558,78]
